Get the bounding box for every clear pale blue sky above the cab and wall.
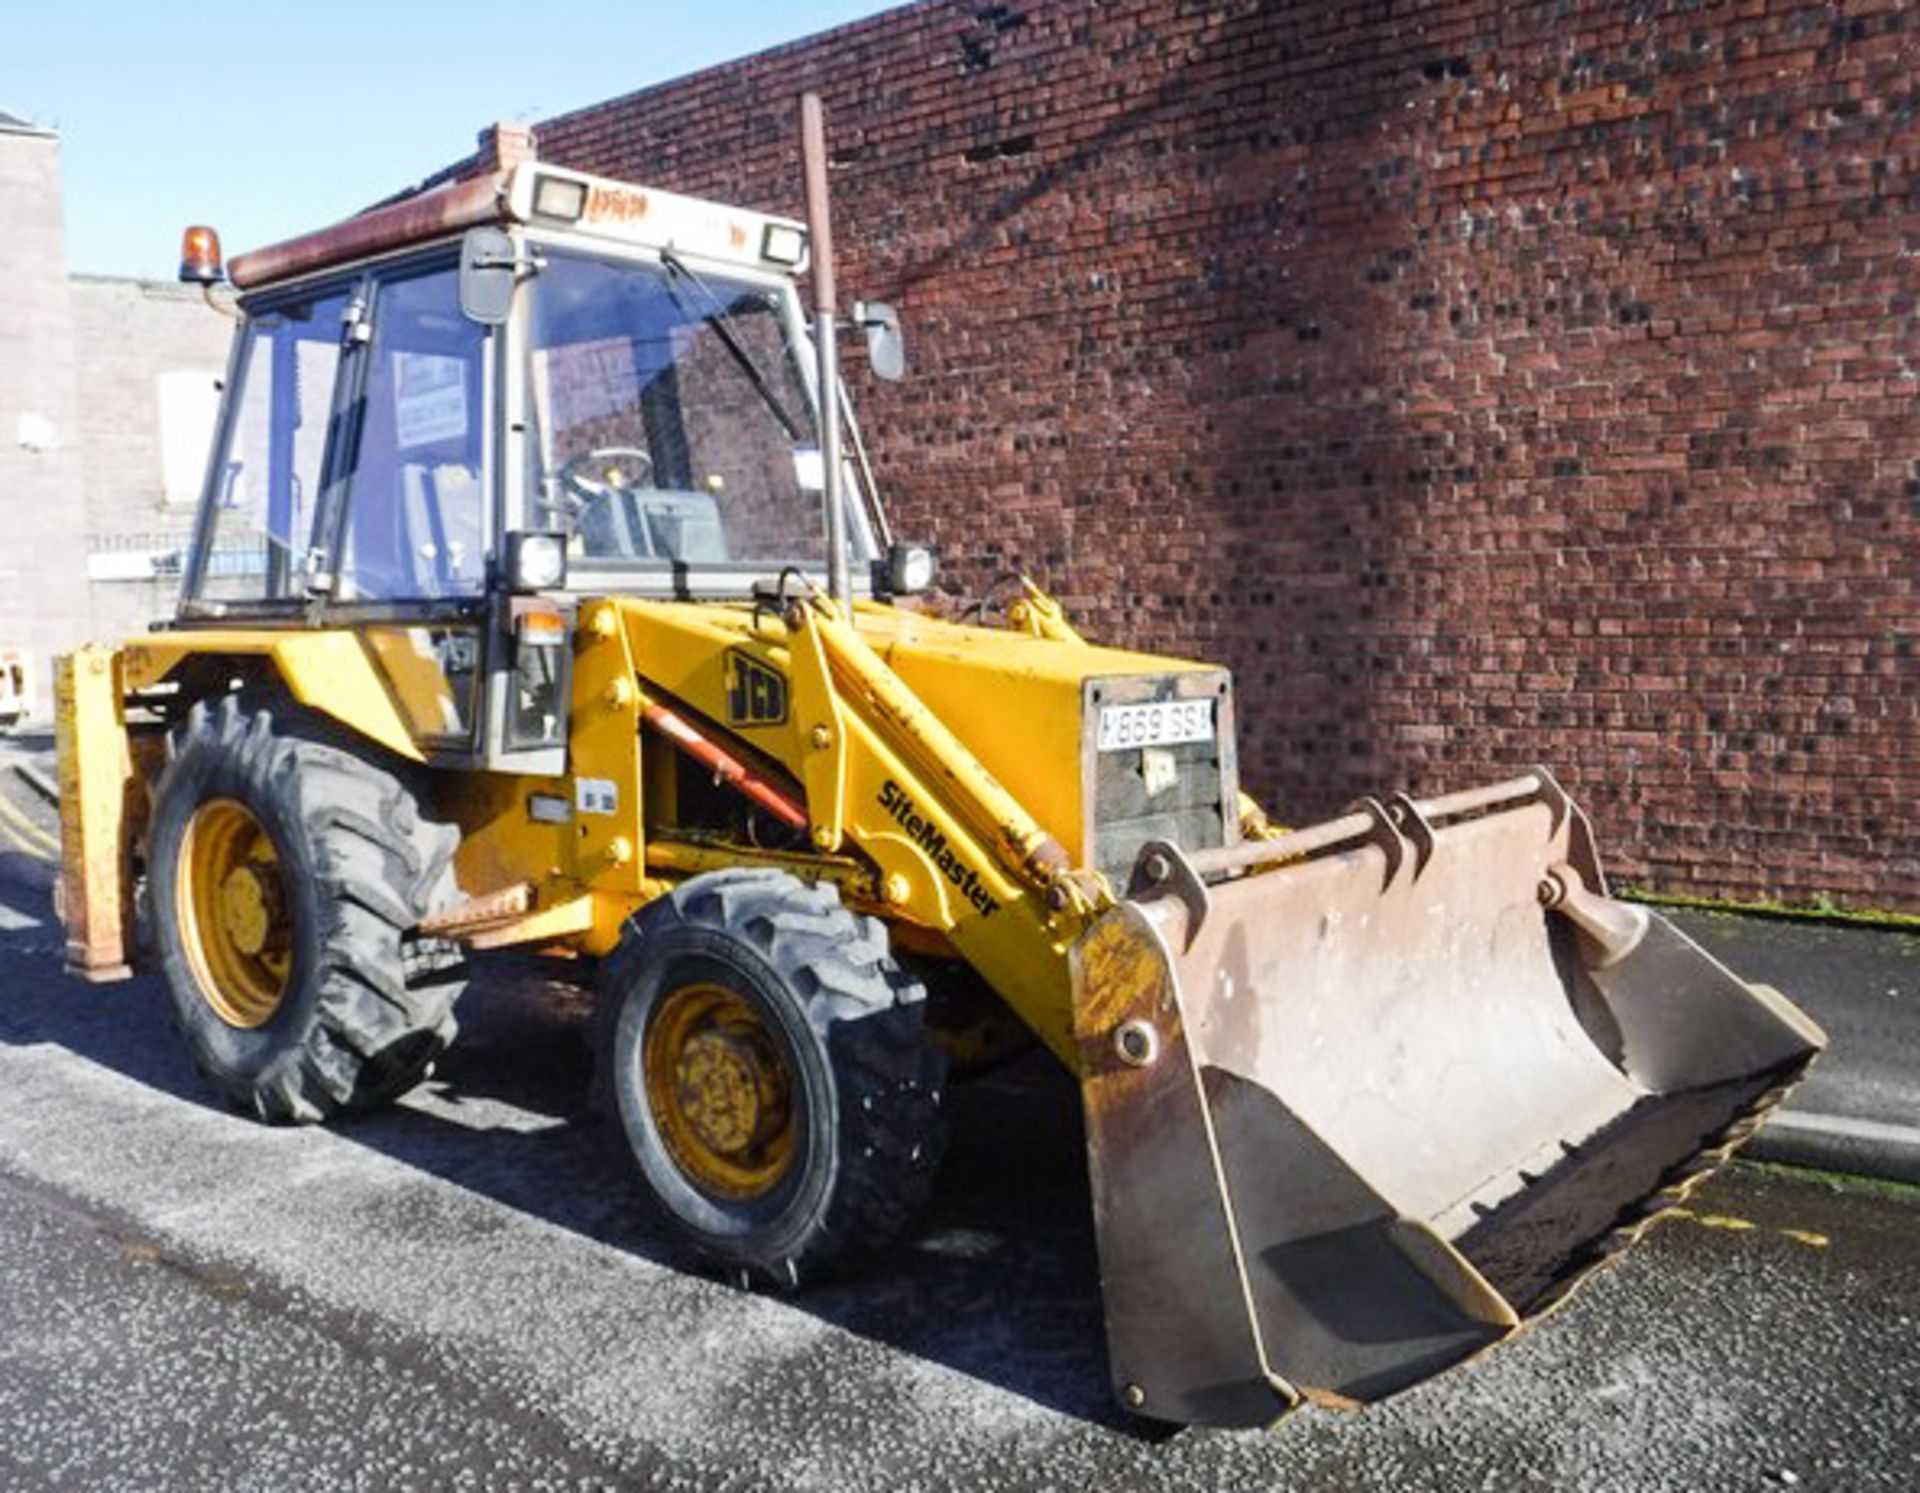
[0,0,893,280]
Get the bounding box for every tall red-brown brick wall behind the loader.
[518,0,1920,910]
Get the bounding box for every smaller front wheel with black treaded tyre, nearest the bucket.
[599,869,947,1290]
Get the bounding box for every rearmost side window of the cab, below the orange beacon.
[196,290,346,601]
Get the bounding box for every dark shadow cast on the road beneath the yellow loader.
[0,865,1121,1434]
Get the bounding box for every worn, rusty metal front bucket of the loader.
[1073,771,1826,1426]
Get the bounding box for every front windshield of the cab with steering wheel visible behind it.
[526,249,862,574]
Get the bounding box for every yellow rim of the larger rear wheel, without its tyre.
[177,798,294,1027]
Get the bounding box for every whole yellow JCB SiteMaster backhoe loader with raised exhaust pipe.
[58,102,1822,1426]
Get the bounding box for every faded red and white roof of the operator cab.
[228,161,806,290]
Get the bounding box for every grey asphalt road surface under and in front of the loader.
[0,736,1920,1489]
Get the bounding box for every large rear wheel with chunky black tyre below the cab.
[148,697,465,1121]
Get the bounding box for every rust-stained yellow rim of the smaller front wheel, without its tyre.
[641,984,795,1199]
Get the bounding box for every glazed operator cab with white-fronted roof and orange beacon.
[175,161,885,773]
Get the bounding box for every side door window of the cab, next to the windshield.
[336,265,488,601]
